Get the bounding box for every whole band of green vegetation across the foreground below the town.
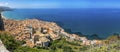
[0,33,120,52]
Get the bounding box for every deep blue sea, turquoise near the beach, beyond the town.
[3,8,120,38]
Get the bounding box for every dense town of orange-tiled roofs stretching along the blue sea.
[3,19,101,47]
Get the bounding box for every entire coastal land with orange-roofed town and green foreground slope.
[0,19,120,52]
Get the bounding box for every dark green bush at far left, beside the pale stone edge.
[0,33,24,51]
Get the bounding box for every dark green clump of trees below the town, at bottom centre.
[50,38,78,52]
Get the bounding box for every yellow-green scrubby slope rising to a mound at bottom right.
[85,35,120,52]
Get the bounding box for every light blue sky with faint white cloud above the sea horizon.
[0,0,120,8]
